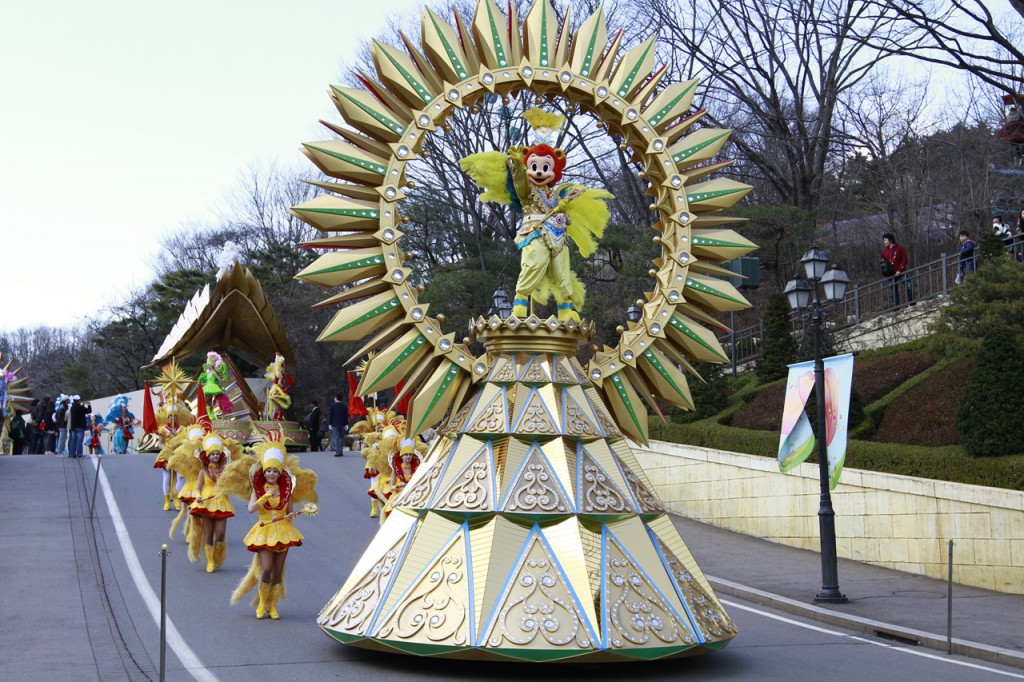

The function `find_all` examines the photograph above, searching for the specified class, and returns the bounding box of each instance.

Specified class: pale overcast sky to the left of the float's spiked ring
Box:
[0,0,424,331]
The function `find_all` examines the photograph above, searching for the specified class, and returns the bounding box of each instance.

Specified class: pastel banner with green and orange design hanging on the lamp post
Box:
[778,353,853,488]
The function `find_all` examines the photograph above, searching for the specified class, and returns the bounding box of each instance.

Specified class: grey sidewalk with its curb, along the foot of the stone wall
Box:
[672,516,1024,668]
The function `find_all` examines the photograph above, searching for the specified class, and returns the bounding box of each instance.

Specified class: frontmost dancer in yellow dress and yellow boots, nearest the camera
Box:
[231,434,317,620]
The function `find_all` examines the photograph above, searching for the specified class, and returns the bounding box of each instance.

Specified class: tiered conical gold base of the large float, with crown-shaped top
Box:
[317,318,736,662]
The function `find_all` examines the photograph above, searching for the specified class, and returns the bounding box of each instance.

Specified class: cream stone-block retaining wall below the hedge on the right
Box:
[635,440,1024,594]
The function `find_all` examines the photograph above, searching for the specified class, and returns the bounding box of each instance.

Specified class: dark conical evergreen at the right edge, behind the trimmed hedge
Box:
[956,321,1024,457]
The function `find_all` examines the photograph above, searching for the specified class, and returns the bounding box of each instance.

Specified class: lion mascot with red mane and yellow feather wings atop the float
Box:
[459,109,612,322]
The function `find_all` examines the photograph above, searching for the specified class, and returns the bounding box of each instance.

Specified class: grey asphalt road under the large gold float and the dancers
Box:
[61,454,1024,682]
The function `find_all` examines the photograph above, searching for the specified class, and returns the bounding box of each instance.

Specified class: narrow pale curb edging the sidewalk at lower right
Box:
[705,574,1024,669]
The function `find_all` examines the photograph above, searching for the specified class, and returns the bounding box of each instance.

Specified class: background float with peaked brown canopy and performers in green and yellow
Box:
[147,248,309,450]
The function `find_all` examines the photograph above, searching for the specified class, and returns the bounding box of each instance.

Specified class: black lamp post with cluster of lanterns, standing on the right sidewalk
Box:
[784,247,850,604]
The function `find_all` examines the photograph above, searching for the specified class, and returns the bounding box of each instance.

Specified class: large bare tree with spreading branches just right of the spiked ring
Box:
[636,0,890,212]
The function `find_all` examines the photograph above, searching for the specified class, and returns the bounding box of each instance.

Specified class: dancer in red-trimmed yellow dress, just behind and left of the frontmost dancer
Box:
[188,432,241,573]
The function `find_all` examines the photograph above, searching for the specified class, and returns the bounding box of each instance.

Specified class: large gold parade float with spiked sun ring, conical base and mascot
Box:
[293,0,755,663]
